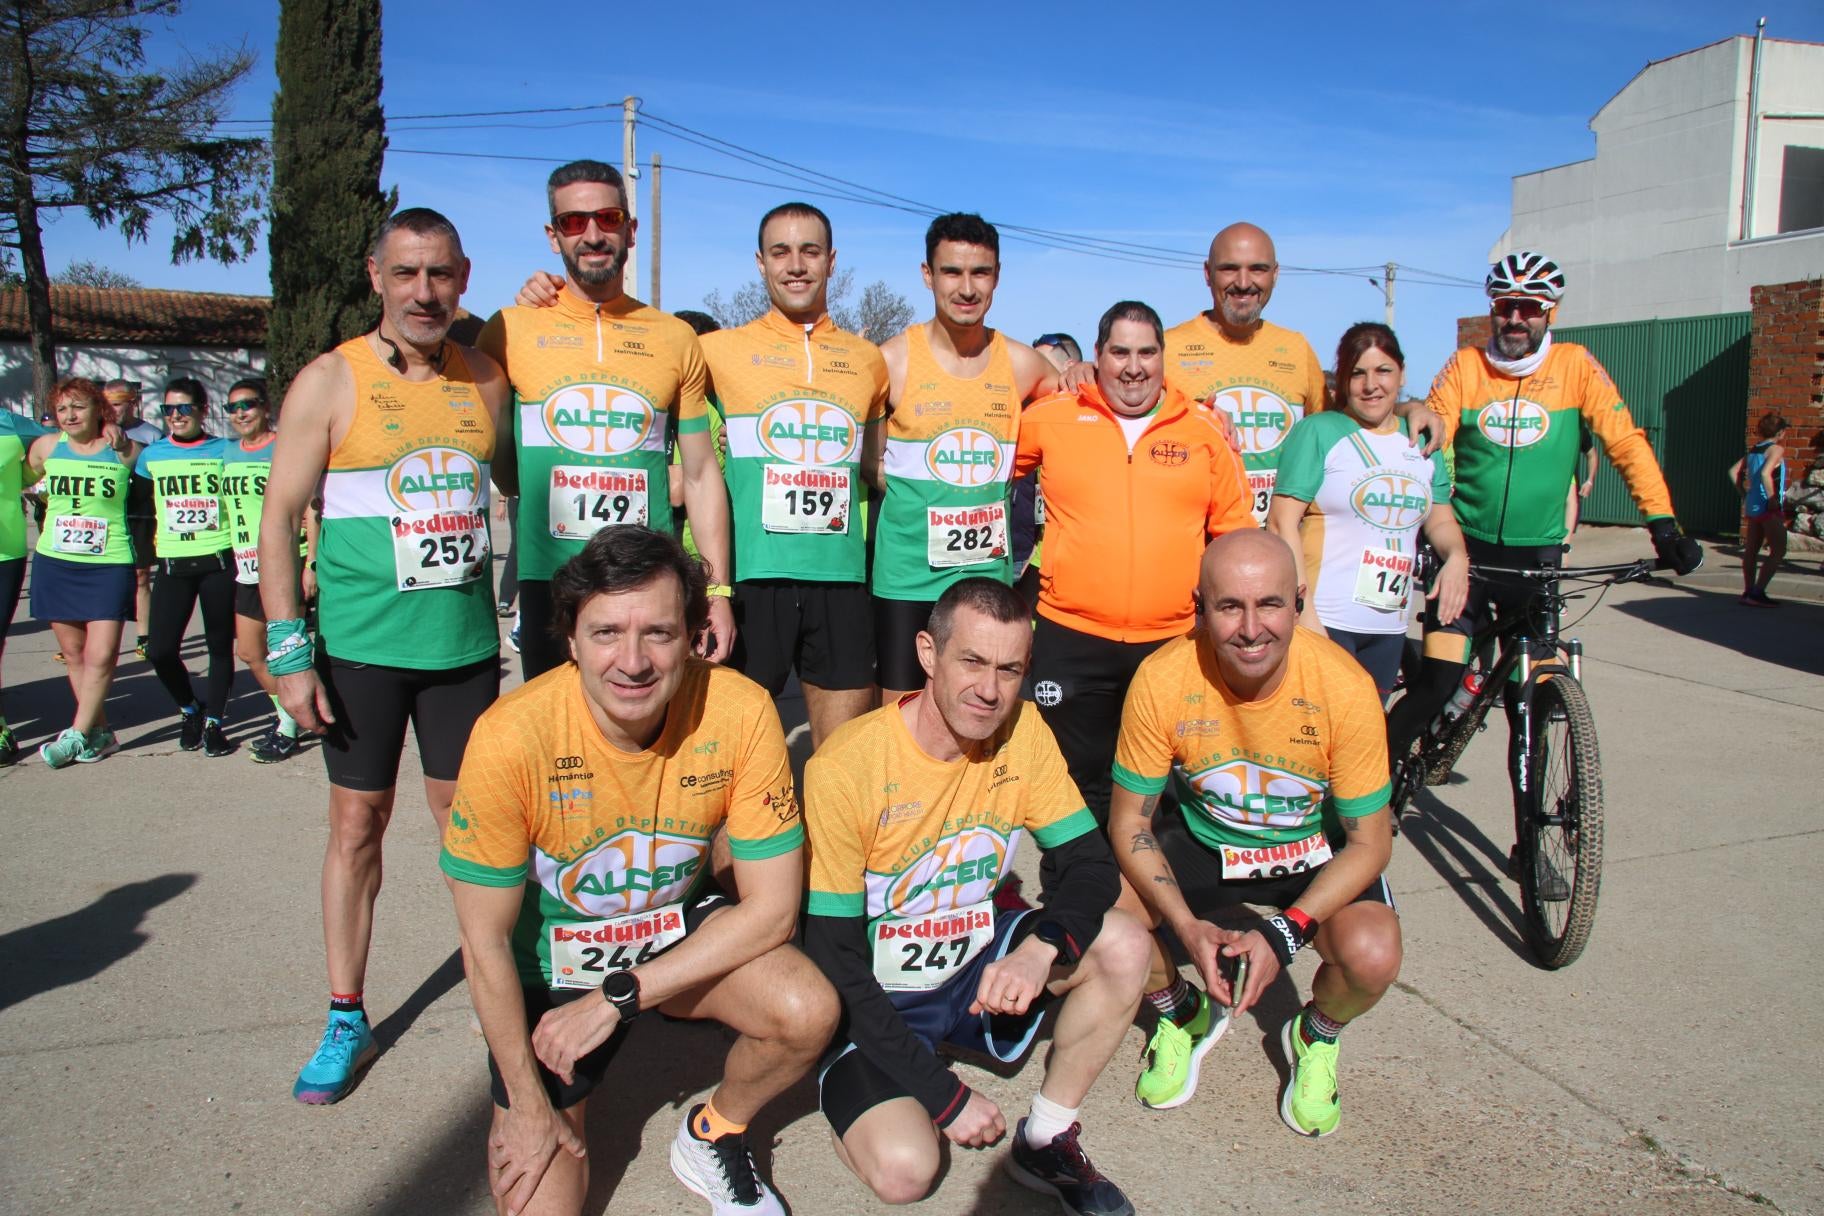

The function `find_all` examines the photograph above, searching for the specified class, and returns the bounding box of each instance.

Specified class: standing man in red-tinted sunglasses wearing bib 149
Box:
[492,160,735,680]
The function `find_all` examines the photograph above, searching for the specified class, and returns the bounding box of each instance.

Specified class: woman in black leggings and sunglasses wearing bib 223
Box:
[133,376,233,757]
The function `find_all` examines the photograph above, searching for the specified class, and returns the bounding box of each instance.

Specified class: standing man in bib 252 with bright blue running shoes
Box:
[259,208,516,1105]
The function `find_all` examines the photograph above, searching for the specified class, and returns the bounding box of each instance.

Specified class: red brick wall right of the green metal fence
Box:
[1742,279,1824,532]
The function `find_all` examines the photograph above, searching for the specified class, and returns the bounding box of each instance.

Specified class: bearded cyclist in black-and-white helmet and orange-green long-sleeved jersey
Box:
[1388,250,1704,901]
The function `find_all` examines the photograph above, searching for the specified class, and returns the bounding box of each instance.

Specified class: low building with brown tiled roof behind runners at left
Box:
[0,284,272,434]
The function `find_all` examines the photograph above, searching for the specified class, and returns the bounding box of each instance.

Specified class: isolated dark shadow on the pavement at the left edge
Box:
[0,873,197,1010]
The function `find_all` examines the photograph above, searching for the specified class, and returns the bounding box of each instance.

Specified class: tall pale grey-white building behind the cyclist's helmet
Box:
[1488,36,1824,325]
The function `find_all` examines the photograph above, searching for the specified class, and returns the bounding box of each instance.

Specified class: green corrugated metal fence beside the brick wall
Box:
[1552,312,1749,536]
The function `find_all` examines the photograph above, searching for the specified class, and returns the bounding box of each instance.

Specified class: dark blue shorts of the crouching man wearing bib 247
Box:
[817,908,1051,1138]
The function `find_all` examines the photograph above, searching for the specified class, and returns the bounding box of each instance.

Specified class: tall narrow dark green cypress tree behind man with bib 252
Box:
[266,0,394,401]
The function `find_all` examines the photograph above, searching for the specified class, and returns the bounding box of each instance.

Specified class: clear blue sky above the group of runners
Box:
[35,0,1824,392]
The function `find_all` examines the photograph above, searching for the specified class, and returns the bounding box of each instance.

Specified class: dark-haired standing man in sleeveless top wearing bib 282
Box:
[866,213,1058,706]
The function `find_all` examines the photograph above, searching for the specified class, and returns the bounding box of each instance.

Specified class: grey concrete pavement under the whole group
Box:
[0,531,1824,1216]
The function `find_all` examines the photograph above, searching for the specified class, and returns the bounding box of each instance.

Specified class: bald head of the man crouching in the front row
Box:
[1197,529,1299,700]
